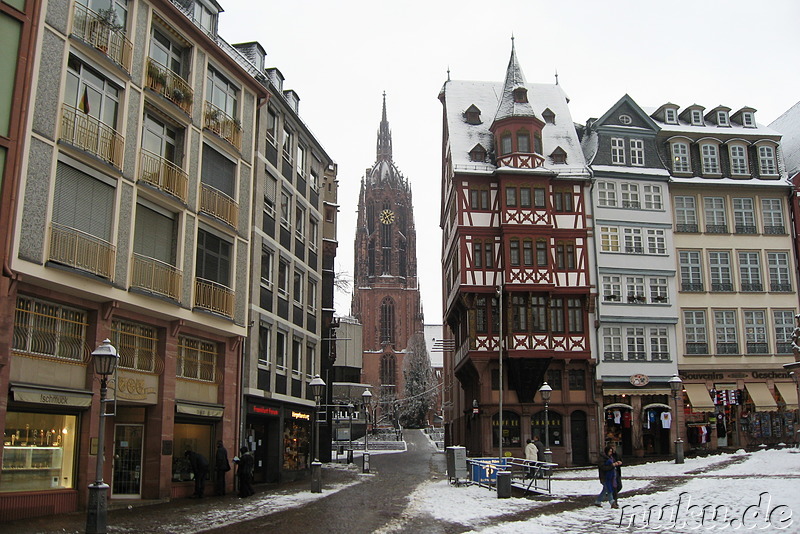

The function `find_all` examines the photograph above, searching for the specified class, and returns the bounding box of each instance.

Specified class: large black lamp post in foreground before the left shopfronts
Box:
[86,339,119,534]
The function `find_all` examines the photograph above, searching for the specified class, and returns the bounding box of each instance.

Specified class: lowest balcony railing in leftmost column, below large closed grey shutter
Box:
[49,223,116,280]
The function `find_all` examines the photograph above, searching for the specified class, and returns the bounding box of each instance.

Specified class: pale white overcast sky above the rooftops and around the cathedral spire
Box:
[219,0,800,324]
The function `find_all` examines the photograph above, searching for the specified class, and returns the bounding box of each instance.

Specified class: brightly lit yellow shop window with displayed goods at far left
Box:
[0,411,78,491]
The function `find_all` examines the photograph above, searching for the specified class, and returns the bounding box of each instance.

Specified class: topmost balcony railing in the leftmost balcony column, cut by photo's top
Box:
[72,2,133,74]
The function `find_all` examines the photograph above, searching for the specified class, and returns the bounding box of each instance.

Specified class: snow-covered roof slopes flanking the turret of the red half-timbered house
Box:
[444,80,586,172]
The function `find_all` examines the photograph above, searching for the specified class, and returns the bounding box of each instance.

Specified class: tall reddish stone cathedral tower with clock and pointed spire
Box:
[352,93,423,420]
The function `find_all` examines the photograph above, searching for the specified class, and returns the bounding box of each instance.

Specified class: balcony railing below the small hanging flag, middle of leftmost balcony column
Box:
[60,104,125,169]
